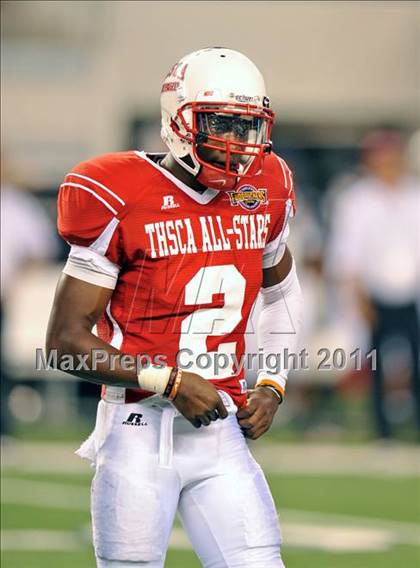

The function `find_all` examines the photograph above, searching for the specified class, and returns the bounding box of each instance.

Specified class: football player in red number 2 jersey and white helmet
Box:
[47,48,301,568]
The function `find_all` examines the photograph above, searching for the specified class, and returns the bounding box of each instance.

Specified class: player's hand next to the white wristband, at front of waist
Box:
[173,371,228,428]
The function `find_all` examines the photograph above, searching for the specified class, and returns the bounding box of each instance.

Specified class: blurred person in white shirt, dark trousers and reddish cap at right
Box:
[327,130,420,438]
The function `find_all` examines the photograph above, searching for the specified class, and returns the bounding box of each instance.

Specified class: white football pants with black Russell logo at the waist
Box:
[77,392,284,568]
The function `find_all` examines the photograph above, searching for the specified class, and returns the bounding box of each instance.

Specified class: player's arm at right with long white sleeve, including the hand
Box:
[237,246,302,440]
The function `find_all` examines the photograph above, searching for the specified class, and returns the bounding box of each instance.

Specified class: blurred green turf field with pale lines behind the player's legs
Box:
[1,446,420,568]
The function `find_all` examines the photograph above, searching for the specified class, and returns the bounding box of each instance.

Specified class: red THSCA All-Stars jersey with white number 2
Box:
[58,151,295,406]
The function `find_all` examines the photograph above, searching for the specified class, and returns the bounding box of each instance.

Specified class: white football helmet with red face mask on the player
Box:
[161,47,274,191]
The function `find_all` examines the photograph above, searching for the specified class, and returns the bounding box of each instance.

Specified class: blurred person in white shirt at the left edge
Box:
[0,163,58,435]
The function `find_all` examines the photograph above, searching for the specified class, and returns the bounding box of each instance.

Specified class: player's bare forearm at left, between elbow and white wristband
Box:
[46,328,139,388]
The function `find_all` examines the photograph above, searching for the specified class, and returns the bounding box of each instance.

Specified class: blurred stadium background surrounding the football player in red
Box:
[1,1,420,568]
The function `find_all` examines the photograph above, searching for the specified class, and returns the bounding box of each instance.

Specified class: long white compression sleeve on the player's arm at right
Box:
[257,261,303,392]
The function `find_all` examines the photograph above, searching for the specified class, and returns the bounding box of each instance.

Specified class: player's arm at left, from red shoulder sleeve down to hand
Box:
[46,158,227,427]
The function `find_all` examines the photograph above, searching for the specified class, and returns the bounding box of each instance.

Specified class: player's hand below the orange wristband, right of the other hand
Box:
[236,387,279,440]
